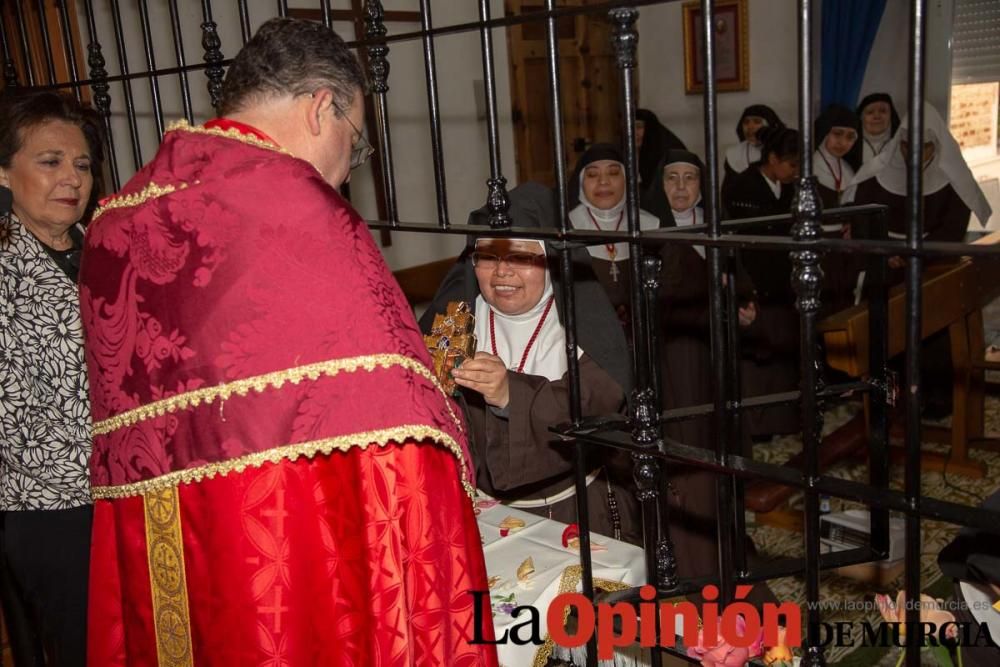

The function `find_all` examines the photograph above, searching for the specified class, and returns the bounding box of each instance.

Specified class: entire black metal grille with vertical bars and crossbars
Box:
[0,0,1000,667]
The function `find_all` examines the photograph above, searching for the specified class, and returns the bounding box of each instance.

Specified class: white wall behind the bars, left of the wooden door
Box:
[80,0,516,269]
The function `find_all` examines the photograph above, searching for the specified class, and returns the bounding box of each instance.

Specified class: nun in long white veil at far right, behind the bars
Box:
[843,104,992,260]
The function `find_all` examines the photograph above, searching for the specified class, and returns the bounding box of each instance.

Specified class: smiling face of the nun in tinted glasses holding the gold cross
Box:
[472,239,546,315]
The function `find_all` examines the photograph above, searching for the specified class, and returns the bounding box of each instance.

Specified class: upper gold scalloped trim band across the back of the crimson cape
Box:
[94,354,462,435]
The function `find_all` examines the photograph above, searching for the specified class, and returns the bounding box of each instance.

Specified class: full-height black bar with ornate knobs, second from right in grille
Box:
[791,0,826,667]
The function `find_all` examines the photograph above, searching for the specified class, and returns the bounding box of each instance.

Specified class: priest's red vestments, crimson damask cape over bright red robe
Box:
[80,125,496,667]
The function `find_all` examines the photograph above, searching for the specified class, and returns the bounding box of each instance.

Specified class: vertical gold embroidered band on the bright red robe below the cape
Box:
[143,488,194,667]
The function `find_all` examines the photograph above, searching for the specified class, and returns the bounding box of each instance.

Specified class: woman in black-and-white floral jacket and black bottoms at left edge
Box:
[0,92,101,667]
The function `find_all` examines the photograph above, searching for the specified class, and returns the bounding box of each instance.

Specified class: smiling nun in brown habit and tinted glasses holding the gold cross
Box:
[421,183,641,543]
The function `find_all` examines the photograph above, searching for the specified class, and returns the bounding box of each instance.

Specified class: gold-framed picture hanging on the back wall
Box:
[683,0,750,94]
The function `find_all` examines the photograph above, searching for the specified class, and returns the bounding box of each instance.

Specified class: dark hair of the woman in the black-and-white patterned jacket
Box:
[0,88,104,171]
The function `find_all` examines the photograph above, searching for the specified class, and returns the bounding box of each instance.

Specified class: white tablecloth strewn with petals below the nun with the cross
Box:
[478,503,646,667]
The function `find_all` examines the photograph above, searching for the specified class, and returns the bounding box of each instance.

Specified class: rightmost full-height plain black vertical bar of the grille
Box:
[903,0,927,667]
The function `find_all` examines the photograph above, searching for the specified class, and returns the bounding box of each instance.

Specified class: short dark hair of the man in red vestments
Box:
[219,18,365,116]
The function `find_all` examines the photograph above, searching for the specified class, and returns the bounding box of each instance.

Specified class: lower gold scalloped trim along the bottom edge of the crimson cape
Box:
[90,424,475,500]
